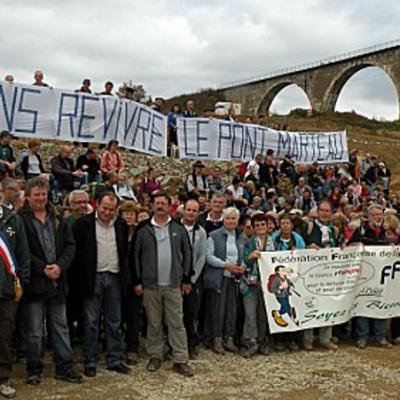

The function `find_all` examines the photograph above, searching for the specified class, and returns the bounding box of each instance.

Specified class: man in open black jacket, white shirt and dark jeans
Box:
[73,192,133,377]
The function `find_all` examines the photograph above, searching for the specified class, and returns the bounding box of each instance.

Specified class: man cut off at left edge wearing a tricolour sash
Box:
[0,205,31,399]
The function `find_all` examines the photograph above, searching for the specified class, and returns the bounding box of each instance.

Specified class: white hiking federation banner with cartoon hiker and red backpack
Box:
[259,246,400,333]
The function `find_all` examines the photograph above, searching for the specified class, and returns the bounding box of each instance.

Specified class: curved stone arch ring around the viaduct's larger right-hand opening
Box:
[323,61,400,112]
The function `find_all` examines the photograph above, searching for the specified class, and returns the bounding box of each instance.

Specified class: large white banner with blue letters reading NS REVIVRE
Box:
[0,82,167,156]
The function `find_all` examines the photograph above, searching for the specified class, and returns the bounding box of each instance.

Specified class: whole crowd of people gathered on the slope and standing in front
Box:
[0,71,400,398]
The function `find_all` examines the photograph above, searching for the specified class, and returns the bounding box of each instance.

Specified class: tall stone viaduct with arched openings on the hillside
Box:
[219,40,400,118]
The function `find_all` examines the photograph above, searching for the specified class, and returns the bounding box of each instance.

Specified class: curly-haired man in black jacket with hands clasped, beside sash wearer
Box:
[20,177,82,385]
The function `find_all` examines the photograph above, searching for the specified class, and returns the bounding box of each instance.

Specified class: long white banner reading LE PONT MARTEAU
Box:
[178,118,348,164]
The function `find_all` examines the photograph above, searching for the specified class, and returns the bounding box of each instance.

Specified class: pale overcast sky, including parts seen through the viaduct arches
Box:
[0,0,400,119]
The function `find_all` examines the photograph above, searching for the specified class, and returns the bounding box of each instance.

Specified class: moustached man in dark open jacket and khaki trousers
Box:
[130,192,193,377]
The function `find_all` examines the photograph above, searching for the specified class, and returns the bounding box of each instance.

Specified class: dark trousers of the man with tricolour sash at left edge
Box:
[0,299,15,384]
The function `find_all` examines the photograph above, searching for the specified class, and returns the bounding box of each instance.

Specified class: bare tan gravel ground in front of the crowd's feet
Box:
[12,345,400,400]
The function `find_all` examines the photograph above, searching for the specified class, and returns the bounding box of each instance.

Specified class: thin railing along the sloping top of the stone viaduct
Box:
[217,39,400,89]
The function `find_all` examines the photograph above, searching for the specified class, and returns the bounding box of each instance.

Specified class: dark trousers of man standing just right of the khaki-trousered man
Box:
[183,279,203,351]
